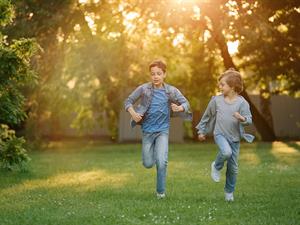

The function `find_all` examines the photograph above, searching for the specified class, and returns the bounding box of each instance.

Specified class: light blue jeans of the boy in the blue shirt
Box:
[142,131,169,193]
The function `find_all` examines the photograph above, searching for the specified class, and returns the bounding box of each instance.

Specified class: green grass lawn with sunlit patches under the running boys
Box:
[0,142,300,225]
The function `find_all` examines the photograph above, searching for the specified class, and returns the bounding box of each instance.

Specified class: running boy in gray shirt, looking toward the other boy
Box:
[196,69,254,201]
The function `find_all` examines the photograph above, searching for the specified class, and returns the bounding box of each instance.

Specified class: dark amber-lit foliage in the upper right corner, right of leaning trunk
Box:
[227,0,300,98]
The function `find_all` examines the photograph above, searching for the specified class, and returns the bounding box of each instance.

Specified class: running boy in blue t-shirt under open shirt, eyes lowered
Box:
[125,60,192,198]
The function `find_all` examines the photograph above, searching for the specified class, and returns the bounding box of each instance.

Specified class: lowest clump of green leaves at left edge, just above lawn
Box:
[0,124,30,170]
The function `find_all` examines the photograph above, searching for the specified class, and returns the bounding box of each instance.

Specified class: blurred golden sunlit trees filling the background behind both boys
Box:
[1,0,300,140]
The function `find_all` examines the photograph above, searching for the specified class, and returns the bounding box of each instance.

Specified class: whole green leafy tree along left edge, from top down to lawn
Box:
[0,0,38,169]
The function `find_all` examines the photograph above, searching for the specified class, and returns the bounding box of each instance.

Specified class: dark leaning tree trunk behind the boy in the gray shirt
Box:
[210,14,276,141]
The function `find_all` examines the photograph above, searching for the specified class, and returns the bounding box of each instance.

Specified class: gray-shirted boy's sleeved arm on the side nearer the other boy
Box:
[196,97,216,136]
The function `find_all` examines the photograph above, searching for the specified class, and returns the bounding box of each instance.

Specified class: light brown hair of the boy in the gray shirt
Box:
[218,68,243,94]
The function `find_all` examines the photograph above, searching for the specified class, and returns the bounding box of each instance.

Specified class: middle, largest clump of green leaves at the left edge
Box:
[0,14,39,125]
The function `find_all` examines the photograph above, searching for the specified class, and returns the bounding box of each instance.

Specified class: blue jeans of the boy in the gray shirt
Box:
[214,134,240,193]
